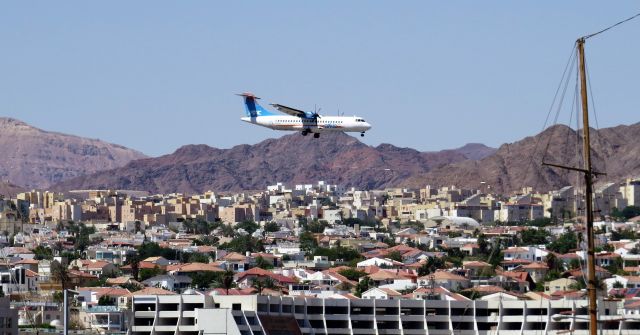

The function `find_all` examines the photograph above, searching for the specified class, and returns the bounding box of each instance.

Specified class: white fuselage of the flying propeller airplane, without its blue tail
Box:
[242,115,371,133]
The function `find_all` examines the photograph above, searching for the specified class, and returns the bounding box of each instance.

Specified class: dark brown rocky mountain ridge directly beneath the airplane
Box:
[56,133,495,193]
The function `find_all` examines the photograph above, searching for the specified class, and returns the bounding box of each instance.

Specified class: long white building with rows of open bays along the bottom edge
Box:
[130,295,640,335]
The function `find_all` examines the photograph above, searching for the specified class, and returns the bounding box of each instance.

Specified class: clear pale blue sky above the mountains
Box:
[0,0,640,156]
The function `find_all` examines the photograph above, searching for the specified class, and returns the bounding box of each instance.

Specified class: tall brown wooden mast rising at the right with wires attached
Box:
[576,37,598,335]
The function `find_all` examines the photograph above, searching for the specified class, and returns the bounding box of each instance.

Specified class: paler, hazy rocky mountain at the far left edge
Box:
[0,117,146,189]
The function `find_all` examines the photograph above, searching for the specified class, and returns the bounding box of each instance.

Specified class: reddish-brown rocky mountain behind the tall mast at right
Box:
[404,123,640,192]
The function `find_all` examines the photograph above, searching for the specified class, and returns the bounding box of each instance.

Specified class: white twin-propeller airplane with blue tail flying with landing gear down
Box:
[237,93,371,138]
